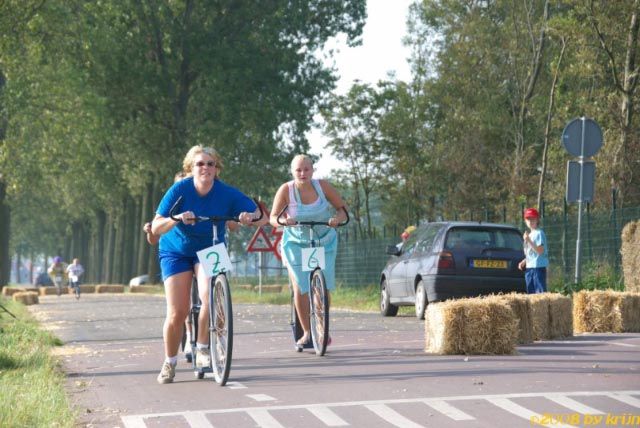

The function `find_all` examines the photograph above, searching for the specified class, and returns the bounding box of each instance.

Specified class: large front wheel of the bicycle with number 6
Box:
[309,269,329,356]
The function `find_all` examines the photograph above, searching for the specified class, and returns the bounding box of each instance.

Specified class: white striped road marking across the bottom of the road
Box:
[122,390,640,428]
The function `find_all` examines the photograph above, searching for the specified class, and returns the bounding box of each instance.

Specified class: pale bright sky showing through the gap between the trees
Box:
[307,0,413,178]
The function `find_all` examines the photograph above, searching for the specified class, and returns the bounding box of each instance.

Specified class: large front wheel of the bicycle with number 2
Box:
[209,274,233,386]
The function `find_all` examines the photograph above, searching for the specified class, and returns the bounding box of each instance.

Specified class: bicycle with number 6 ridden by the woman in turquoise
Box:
[276,205,349,356]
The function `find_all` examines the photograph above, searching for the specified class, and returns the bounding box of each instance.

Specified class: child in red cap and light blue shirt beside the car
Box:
[518,208,549,294]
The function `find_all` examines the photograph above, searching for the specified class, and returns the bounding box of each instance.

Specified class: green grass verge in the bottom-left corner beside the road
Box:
[0,298,76,427]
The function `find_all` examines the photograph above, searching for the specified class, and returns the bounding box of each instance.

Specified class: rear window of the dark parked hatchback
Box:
[445,227,522,251]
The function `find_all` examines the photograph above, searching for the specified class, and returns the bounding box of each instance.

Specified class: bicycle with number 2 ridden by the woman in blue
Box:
[169,197,264,386]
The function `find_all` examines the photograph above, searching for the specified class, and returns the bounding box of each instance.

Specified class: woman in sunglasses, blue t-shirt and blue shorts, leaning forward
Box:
[151,146,266,383]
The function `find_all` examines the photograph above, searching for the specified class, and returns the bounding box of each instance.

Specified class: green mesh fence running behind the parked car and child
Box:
[232,200,640,287]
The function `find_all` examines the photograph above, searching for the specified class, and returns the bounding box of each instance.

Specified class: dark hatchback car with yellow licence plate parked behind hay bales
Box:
[380,222,526,319]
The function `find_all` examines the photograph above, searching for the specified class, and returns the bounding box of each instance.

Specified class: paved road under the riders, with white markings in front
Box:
[30,294,640,428]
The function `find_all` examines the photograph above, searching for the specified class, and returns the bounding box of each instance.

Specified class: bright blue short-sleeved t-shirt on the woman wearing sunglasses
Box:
[156,177,257,257]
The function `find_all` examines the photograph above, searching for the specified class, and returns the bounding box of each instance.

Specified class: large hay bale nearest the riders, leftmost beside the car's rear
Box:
[425,296,518,355]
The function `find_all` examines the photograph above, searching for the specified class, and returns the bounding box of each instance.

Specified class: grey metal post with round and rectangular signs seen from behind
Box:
[562,117,602,284]
